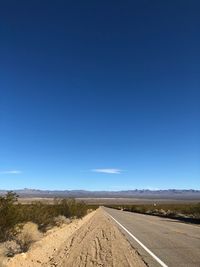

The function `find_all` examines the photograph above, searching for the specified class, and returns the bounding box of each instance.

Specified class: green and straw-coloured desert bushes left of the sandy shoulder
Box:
[0,192,95,256]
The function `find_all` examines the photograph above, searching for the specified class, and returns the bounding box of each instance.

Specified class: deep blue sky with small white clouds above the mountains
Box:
[0,0,200,190]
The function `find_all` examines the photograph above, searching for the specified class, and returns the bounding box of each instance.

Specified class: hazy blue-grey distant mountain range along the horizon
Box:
[0,188,200,200]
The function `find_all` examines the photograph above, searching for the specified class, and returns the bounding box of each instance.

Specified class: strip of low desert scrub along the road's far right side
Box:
[108,203,200,223]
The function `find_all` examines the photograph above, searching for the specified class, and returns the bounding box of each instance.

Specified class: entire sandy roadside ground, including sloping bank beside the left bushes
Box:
[4,209,146,267]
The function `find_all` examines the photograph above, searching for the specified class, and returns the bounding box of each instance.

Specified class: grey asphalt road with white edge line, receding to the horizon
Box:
[103,207,200,267]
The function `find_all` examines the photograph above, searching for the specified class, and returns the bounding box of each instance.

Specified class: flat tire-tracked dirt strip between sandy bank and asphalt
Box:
[46,209,146,267]
